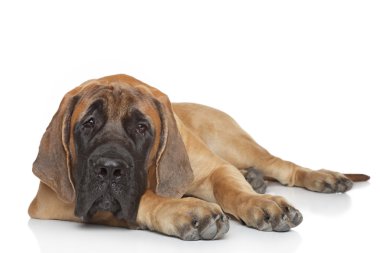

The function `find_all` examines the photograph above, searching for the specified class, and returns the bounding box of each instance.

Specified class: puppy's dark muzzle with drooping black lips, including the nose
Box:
[75,146,145,221]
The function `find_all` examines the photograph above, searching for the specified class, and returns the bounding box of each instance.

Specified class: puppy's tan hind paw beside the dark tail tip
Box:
[303,170,353,193]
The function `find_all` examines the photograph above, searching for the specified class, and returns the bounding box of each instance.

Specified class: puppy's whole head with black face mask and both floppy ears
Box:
[33,75,193,222]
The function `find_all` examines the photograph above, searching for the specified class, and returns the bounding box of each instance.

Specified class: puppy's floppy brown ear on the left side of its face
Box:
[33,88,79,202]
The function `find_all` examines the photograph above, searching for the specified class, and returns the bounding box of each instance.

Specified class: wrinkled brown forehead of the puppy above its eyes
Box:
[73,80,159,122]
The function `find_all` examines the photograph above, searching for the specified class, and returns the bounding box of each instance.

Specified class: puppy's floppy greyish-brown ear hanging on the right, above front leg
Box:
[155,92,193,198]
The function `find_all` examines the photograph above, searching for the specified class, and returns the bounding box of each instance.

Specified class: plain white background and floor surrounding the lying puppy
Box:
[0,0,380,252]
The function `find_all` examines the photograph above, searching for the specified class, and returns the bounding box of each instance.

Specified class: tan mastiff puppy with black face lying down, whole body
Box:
[29,75,369,240]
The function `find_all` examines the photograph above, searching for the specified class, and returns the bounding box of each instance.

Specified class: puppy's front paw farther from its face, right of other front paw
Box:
[238,195,302,232]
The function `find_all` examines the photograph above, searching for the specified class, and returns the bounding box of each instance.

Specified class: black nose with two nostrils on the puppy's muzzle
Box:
[95,157,128,179]
